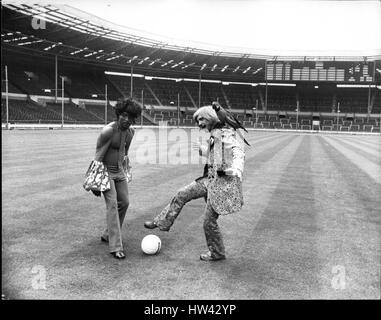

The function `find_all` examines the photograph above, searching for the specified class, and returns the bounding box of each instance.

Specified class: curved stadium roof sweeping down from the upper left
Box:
[1,3,381,80]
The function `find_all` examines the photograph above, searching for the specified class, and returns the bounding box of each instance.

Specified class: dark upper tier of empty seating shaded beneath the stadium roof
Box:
[2,65,381,113]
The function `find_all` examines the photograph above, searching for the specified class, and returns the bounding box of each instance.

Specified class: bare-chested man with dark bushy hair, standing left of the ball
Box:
[93,98,142,259]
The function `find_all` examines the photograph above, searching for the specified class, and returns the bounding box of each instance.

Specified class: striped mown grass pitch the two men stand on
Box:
[2,129,381,300]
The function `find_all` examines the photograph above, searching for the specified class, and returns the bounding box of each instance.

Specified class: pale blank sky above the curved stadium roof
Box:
[6,0,381,55]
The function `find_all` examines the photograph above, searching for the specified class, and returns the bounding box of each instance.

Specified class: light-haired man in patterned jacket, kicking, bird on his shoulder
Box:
[144,106,245,261]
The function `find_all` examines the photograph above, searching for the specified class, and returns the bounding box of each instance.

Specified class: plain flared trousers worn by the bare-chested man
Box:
[102,168,129,252]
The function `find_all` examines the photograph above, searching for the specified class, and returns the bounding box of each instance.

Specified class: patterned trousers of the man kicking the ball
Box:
[154,178,225,257]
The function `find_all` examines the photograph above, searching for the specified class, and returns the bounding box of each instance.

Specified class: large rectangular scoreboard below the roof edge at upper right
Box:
[266,61,374,83]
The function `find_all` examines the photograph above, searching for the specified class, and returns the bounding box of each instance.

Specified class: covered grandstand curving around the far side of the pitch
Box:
[1,5,381,132]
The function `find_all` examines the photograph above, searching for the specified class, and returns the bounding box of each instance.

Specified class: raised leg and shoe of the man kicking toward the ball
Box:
[144,178,207,231]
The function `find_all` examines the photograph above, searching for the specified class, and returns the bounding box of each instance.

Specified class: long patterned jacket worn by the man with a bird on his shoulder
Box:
[200,127,245,215]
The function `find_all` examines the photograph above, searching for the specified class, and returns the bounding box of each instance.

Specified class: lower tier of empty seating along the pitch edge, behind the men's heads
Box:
[1,99,381,132]
